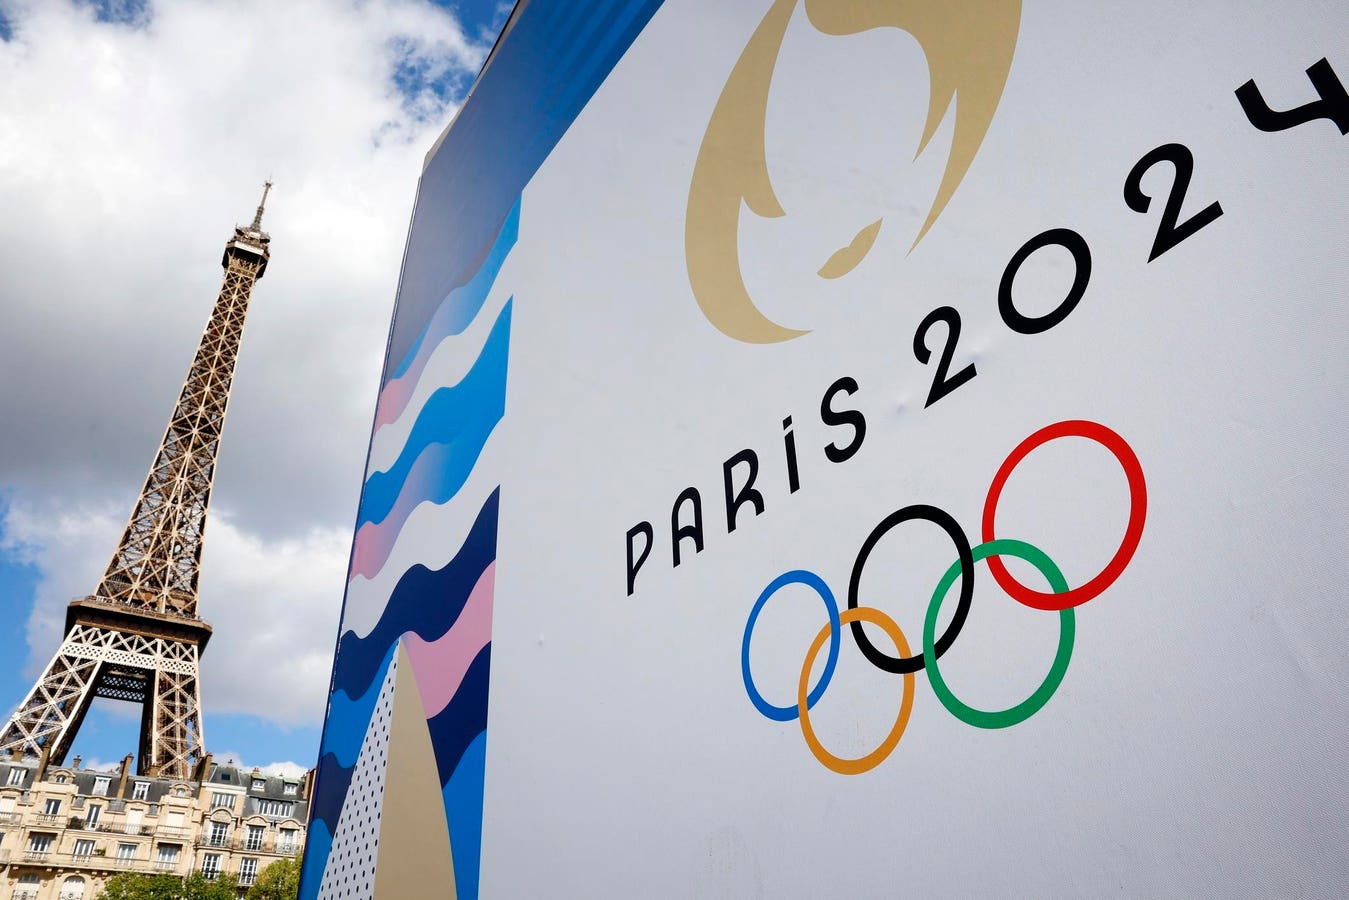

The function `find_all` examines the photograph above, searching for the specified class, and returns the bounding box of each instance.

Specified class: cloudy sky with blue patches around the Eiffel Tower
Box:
[0,0,509,768]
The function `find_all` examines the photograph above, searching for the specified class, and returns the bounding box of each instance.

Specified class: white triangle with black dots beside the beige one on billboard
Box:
[318,654,398,900]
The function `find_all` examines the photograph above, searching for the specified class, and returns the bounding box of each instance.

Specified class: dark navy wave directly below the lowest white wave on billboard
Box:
[329,487,500,701]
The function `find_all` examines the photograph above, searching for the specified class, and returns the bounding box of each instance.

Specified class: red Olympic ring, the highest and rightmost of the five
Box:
[983,420,1148,611]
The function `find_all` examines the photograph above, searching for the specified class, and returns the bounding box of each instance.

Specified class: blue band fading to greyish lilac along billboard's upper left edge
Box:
[382,0,661,383]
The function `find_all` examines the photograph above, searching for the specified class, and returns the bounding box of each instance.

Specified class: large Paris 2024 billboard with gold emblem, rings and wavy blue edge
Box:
[302,0,1349,897]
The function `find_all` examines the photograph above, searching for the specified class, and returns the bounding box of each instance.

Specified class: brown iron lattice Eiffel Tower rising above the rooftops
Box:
[0,182,271,779]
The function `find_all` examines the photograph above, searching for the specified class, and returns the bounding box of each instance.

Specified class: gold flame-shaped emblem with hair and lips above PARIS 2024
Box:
[684,0,1021,344]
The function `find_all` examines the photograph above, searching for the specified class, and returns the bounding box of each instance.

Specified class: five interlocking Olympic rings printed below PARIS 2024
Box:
[741,420,1148,775]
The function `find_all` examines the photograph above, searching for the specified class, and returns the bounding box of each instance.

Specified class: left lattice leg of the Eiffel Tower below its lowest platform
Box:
[0,626,104,765]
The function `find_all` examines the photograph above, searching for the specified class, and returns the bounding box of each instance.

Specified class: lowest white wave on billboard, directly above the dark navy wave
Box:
[341,425,505,637]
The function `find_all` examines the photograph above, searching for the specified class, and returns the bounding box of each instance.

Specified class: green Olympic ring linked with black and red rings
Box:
[923,538,1077,729]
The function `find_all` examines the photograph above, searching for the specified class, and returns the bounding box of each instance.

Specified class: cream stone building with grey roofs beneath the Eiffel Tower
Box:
[0,754,313,900]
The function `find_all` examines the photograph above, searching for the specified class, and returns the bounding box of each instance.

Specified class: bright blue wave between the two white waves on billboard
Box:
[356,302,511,528]
